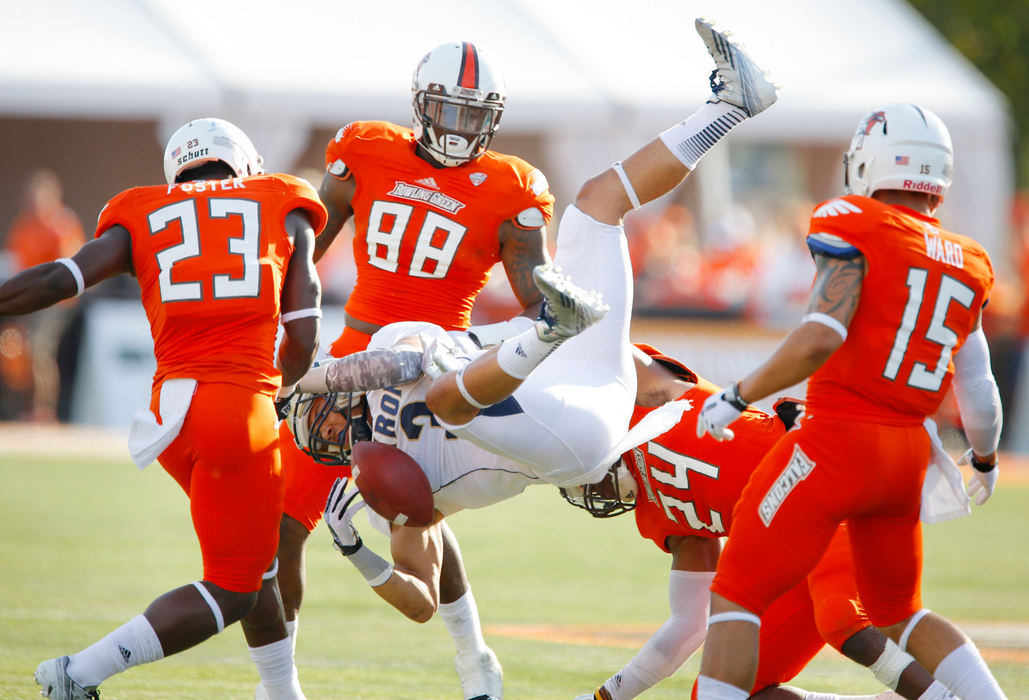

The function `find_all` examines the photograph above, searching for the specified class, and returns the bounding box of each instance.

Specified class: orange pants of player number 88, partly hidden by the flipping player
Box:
[279,327,371,532]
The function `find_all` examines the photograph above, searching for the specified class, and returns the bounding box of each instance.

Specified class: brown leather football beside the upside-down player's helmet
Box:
[351,441,435,527]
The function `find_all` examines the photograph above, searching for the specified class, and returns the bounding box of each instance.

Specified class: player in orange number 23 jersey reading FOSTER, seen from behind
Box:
[0,118,325,700]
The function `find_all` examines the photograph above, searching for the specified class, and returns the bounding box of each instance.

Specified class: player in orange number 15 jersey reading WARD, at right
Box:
[698,104,1004,700]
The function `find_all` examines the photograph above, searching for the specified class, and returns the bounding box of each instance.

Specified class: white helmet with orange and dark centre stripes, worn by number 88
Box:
[411,41,507,168]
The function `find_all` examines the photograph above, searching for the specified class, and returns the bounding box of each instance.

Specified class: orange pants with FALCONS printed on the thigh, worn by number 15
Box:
[711,416,929,626]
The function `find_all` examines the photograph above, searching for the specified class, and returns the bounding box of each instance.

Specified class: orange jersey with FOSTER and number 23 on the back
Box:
[96,174,326,393]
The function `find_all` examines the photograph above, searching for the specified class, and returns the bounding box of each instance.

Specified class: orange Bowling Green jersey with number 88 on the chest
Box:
[325,121,554,330]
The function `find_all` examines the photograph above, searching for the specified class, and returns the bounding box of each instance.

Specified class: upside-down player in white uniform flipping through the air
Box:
[281,20,777,697]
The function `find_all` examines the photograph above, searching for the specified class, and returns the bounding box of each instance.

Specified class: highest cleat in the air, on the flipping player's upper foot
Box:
[697,18,779,116]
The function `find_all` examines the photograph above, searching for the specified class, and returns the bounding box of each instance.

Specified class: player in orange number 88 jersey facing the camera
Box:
[269,42,554,698]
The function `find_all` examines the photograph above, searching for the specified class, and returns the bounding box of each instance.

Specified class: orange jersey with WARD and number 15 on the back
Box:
[807,195,993,425]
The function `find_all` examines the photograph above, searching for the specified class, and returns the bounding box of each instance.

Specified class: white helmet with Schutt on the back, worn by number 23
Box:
[165,117,264,184]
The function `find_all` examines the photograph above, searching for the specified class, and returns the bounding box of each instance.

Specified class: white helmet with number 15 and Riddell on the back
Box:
[843,104,954,200]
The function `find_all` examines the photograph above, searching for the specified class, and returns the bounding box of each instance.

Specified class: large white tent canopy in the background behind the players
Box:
[0,0,1014,254]
